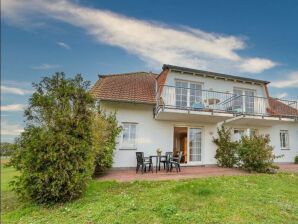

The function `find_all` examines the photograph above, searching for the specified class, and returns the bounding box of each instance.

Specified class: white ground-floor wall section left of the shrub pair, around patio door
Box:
[101,102,216,167]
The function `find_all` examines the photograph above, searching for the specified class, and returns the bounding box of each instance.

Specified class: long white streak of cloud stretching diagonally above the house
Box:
[2,0,276,73]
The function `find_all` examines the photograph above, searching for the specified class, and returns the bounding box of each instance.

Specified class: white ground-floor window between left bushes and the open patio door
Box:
[120,122,137,149]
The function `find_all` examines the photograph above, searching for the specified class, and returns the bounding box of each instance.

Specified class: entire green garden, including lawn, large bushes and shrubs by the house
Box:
[1,73,298,223]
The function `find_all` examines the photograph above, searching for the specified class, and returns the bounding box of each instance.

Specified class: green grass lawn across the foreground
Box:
[1,164,298,224]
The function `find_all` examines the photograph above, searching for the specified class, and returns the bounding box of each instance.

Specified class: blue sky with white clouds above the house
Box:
[1,0,298,142]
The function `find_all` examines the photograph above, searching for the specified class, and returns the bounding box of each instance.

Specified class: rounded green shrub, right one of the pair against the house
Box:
[238,135,280,173]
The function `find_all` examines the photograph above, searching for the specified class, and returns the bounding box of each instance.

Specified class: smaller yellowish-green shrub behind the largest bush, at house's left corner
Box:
[92,109,121,176]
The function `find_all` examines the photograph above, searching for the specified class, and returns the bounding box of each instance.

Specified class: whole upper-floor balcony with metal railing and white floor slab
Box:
[155,86,298,124]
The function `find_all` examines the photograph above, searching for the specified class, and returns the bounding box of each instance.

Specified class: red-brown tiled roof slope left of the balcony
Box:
[91,72,157,104]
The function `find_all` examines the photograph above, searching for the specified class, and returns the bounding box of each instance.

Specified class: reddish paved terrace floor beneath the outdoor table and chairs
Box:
[98,164,298,182]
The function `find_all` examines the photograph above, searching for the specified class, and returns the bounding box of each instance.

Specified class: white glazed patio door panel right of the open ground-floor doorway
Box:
[188,128,202,165]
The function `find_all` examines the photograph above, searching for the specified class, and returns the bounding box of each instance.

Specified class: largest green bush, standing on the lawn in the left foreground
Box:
[11,73,95,203]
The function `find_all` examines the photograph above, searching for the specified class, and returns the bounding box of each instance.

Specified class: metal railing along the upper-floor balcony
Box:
[156,85,298,118]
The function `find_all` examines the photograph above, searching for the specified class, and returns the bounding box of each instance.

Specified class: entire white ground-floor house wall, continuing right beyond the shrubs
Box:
[101,102,298,167]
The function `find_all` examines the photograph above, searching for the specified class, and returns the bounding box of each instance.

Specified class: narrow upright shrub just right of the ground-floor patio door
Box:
[213,126,238,167]
